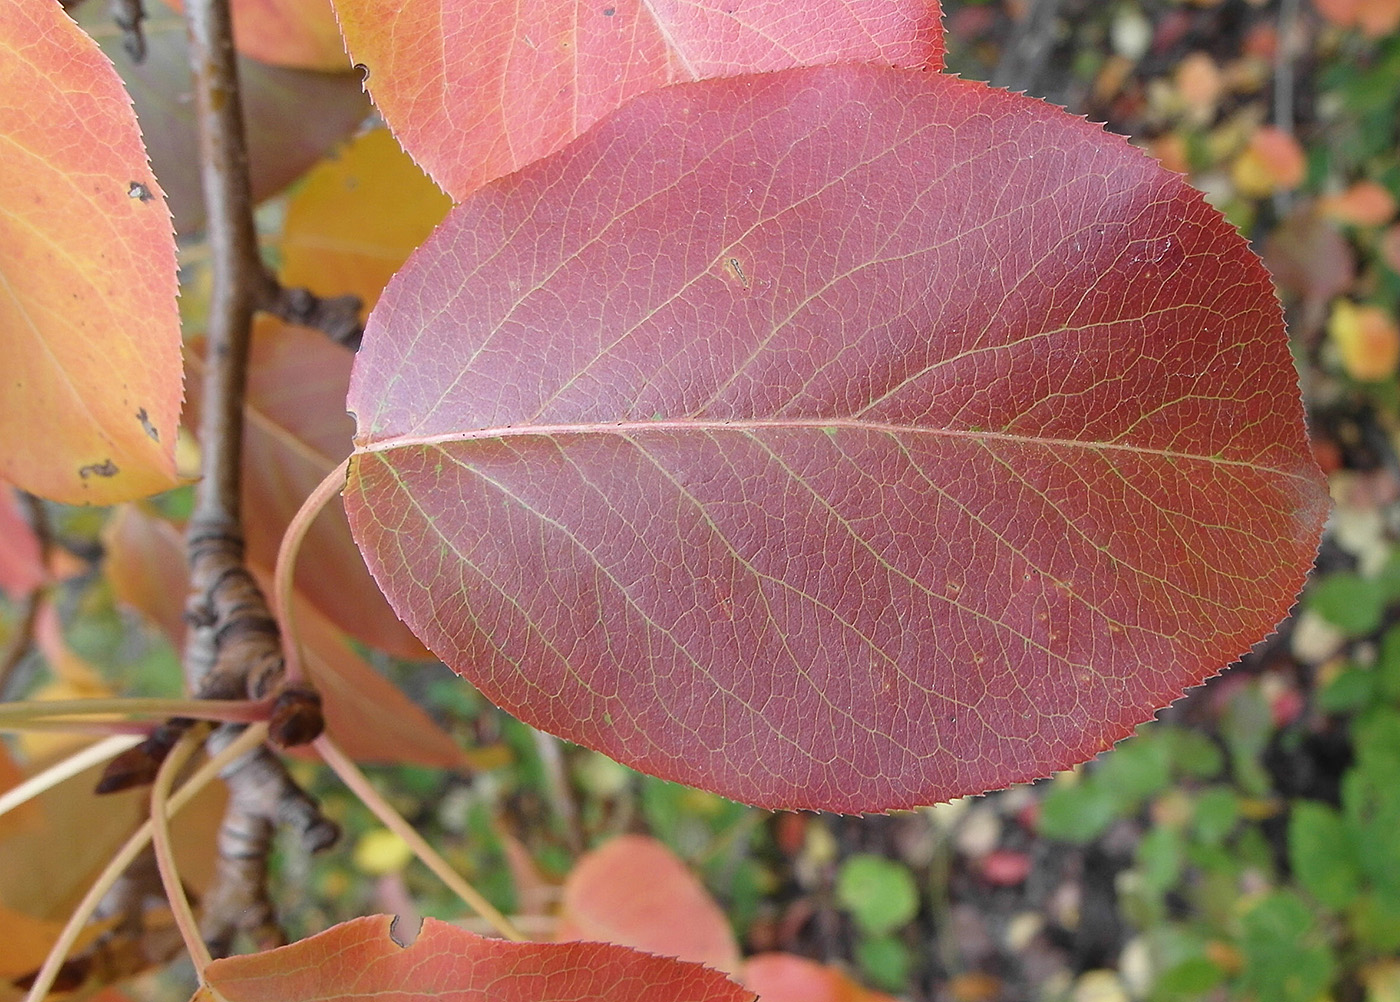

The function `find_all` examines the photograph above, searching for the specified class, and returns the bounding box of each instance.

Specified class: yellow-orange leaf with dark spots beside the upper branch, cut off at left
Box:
[0,0,181,504]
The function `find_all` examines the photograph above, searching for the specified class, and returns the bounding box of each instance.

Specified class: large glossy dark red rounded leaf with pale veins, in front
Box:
[346,66,1327,812]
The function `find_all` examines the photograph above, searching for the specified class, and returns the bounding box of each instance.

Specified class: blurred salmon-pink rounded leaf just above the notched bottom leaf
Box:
[554,835,739,971]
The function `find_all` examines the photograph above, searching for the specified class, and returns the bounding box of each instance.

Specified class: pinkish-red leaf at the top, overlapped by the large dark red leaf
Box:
[333,0,944,199]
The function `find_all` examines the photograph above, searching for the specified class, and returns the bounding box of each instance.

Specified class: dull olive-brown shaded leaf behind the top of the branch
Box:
[74,3,370,234]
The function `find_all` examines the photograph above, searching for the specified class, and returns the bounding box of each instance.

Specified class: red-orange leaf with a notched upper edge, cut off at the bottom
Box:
[195,915,753,1002]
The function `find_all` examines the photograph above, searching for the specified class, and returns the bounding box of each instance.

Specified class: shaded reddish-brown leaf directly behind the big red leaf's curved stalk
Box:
[186,316,426,658]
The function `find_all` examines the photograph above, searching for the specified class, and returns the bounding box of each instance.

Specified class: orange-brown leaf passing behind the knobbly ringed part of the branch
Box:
[104,508,470,768]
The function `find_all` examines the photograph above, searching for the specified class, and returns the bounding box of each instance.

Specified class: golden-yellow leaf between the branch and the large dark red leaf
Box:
[281,129,452,309]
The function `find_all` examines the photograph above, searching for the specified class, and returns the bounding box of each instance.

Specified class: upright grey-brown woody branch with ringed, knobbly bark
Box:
[176,0,336,956]
